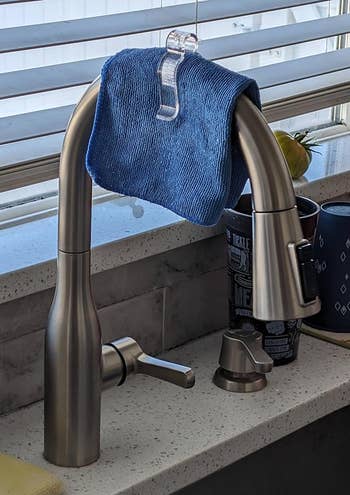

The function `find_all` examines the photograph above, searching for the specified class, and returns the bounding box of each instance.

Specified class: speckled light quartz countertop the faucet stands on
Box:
[0,333,350,495]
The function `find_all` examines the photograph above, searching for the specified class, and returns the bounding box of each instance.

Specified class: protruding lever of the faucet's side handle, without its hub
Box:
[103,337,195,388]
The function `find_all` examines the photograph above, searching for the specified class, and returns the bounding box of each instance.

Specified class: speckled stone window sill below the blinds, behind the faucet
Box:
[0,135,350,303]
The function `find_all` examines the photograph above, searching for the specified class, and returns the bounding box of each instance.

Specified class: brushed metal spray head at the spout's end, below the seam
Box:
[253,207,321,321]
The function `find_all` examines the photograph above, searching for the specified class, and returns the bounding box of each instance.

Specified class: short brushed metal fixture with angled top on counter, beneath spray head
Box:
[213,329,273,392]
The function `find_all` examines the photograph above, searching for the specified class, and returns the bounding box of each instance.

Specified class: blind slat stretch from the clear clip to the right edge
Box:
[200,14,350,60]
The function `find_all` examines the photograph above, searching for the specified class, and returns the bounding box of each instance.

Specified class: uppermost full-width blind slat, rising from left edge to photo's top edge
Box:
[0,0,326,53]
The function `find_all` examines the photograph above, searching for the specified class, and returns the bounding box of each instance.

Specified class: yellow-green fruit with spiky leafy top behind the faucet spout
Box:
[274,131,318,179]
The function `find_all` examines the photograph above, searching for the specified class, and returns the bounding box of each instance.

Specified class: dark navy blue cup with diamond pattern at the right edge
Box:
[305,201,350,333]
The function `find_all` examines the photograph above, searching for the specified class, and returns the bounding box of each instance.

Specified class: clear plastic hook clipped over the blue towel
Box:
[157,30,198,121]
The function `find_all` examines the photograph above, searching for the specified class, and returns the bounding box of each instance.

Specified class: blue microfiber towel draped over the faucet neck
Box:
[86,48,260,226]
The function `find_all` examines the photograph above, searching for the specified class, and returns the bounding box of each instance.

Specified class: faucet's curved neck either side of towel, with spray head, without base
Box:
[59,78,319,320]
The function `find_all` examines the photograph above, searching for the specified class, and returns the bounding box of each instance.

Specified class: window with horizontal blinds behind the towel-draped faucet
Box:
[0,0,350,197]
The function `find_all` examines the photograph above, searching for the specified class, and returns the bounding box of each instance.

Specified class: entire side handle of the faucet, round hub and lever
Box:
[102,337,195,388]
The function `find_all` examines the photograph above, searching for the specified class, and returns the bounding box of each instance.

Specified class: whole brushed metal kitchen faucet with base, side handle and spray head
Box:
[44,78,319,467]
